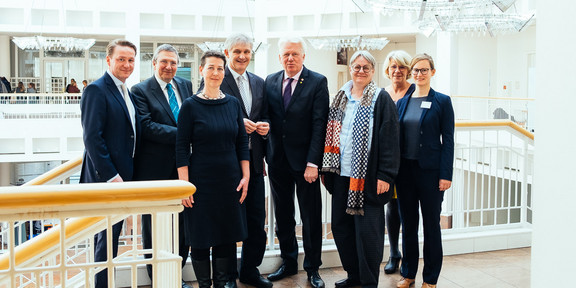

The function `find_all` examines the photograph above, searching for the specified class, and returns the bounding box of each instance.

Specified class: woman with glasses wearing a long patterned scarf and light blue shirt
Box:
[321,51,400,288]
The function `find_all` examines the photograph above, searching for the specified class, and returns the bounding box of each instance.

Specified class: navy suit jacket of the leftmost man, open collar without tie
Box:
[80,72,140,183]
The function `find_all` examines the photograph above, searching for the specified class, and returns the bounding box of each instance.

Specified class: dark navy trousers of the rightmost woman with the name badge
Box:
[396,158,444,284]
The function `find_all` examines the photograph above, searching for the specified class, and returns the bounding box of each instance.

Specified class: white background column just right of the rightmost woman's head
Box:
[434,32,458,95]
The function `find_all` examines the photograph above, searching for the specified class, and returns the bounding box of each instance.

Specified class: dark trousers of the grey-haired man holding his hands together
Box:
[230,164,267,279]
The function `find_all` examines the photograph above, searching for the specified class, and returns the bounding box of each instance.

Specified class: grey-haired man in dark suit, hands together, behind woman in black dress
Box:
[199,34,272,288]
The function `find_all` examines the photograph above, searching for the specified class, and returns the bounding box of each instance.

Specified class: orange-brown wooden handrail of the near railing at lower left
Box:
[0,180,196,270]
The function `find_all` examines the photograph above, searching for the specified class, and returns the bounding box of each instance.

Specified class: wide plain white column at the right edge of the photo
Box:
[530,0,576,287]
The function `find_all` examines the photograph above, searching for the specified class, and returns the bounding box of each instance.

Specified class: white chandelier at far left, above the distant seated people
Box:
[12,36,96,52]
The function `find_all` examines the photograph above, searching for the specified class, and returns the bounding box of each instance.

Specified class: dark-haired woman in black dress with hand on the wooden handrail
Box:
[176,51,250,287]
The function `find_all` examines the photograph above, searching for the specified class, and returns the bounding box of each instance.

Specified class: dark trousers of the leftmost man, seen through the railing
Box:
[94,220,124,288]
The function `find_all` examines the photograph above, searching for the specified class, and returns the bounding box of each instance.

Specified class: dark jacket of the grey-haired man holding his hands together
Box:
[198,66,270,173]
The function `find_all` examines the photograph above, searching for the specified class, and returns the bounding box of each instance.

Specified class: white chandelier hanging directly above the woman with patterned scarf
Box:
[308,36,390,51]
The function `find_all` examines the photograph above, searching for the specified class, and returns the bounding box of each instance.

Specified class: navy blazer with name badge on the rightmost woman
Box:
[397,89,454,181]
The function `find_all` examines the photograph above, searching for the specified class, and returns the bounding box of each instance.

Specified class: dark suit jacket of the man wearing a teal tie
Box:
[132,76,193,180]
